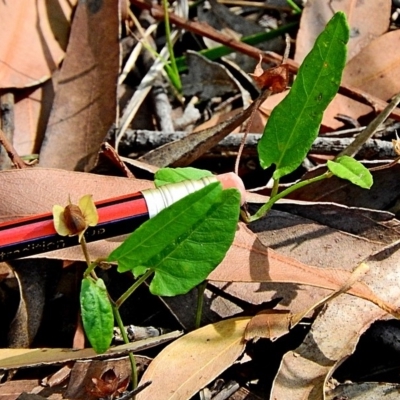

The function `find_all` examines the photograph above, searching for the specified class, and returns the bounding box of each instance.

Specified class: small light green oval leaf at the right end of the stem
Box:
[327,156,373,189]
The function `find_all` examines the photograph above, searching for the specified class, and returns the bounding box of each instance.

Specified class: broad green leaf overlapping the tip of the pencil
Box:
[108,182,240,296]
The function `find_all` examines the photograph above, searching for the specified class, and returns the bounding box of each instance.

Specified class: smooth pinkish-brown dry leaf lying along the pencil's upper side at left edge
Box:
[0,168,154,222]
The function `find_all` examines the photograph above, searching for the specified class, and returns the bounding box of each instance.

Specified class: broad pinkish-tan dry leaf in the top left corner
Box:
[0,0,77,88]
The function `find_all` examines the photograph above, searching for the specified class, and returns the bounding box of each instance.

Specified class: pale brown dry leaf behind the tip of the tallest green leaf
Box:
[294,0,391,63]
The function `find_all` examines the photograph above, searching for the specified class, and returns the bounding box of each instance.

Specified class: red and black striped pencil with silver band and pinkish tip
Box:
[0,173,244,261]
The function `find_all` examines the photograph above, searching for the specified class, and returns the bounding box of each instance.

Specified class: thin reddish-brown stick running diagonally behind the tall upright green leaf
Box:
[130,0,400,121]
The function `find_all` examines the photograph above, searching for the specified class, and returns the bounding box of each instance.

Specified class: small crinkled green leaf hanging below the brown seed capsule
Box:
[80,278,114,353]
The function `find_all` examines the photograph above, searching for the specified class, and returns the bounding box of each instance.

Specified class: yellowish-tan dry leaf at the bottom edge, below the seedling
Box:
[136,318,250,400]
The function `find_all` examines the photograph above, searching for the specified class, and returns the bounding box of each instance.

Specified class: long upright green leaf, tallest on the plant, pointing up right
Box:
[258,12,349,179]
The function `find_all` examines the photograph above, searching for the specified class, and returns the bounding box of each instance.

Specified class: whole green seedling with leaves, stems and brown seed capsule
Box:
[54,12,373,387]
